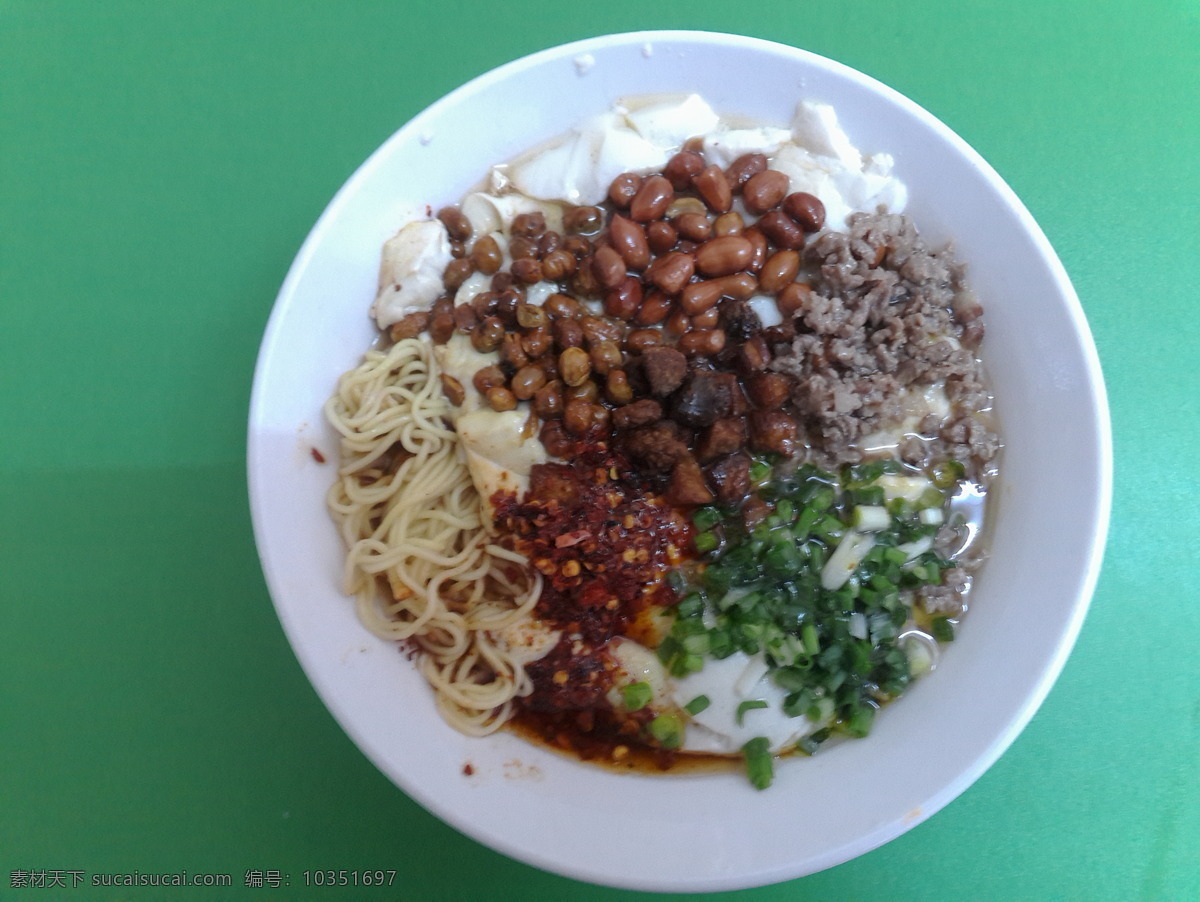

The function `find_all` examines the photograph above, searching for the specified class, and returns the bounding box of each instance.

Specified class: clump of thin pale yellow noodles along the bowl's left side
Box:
[325,338,541,735]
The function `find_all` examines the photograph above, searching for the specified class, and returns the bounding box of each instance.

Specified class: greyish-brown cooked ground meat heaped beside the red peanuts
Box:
[772,214,1000,479]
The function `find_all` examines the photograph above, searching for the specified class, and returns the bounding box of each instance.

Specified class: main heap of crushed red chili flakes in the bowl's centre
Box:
[493,443,691,644]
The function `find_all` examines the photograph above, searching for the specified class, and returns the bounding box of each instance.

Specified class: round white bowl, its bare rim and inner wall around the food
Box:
[248,31,1111,891]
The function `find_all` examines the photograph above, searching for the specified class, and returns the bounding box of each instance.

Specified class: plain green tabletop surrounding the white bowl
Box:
[0,0,1200,900]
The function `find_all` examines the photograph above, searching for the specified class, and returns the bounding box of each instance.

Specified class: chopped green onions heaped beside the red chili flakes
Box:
[652,457,965,786]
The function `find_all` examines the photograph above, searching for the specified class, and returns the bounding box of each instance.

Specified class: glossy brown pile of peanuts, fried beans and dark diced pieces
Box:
[391,146,824,505]
